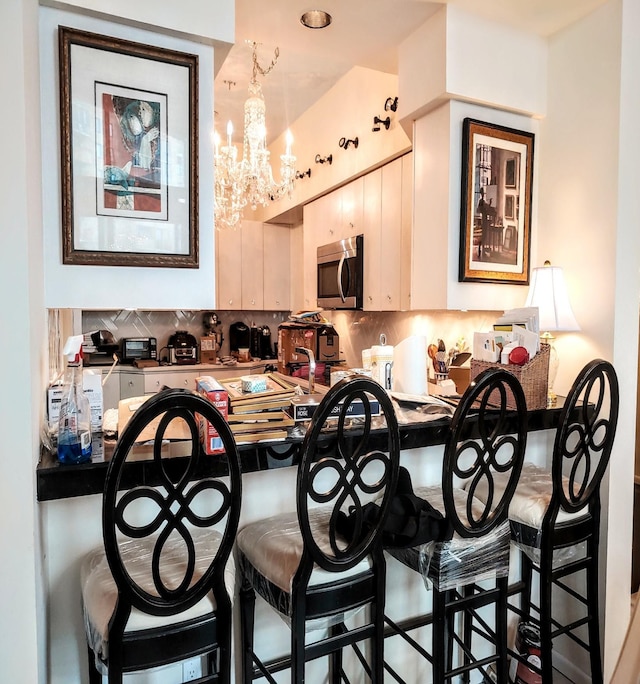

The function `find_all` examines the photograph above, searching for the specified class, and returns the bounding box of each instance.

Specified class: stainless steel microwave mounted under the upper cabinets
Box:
[318,235,364,309]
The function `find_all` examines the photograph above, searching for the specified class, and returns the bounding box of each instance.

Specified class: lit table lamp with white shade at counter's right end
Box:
[525,261,580,406]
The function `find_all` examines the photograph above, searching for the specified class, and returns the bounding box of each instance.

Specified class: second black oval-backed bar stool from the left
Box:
[236,376,400,684]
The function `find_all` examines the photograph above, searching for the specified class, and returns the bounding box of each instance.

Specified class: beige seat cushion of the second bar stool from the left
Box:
[236,508,371,593]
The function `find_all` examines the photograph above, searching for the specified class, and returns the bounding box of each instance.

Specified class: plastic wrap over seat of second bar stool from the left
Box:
[236,507,371,632]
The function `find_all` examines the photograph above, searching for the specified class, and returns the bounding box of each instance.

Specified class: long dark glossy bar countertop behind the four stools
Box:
[36,398,562,501]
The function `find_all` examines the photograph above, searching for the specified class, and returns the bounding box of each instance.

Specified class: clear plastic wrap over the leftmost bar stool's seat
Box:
[80,529,235,673]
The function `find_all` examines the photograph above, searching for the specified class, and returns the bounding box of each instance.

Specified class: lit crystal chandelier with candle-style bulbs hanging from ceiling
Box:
[214,42,296,229]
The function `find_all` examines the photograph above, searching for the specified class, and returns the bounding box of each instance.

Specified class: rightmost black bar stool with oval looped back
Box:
[480,359,619,682]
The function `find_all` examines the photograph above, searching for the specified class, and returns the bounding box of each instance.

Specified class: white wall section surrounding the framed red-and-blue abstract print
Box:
[40,3,220,309]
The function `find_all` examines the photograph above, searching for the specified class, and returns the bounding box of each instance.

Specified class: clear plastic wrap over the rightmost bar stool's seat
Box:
[476,463,583,567]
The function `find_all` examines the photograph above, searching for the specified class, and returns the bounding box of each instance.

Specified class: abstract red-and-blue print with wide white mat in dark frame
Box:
[58,26,198,268]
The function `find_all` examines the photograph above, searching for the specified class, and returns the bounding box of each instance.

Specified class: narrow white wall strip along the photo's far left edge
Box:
[0,0,46,684]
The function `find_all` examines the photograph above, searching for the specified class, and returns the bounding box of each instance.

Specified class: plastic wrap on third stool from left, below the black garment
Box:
[389,486,511,591]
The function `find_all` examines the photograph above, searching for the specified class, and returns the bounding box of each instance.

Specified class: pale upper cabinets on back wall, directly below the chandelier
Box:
[216,221,291,311]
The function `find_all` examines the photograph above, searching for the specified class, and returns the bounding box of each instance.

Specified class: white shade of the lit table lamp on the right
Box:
[526,265,580,332]
